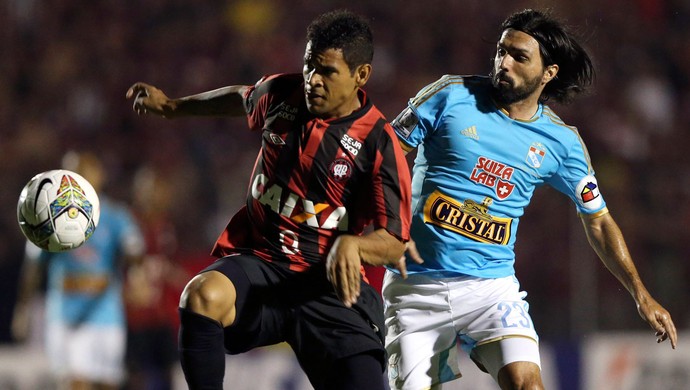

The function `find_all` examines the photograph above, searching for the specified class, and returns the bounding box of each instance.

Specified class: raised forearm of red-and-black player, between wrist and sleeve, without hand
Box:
[171,85,247,117]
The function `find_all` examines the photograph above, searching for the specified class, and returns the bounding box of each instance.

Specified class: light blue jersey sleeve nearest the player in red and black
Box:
[391,75,463,149]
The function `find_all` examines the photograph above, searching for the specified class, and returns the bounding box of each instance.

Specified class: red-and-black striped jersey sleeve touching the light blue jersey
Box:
[373,123,412,241]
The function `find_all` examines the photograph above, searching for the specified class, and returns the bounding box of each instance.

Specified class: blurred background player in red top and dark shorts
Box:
[124,165,191,390]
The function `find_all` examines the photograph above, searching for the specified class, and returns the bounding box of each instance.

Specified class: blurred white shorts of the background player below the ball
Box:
[46,323,127,385]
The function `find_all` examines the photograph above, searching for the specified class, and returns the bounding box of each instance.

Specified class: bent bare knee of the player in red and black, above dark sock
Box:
[180,271,236,326]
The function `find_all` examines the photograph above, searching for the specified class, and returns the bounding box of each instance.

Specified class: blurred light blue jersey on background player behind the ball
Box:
[27,197,144,326]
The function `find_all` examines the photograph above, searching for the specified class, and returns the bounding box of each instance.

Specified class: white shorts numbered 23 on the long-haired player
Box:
[383,271,541,390]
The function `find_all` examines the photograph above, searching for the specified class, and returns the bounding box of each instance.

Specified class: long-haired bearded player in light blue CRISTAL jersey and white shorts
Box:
[383,10,677,390]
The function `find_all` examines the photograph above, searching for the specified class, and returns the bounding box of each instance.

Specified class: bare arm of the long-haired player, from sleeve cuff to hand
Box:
[582,212,678,349]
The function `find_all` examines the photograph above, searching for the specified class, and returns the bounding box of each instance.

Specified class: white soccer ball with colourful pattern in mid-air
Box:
[17,169,101,252]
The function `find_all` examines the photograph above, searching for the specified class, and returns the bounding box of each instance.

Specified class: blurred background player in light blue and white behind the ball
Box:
[12,152,144,390]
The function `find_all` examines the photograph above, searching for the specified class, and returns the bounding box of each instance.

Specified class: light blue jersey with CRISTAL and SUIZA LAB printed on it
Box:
[393,75,606,278]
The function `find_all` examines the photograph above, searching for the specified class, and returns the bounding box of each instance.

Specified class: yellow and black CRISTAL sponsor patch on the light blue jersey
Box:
[424,191,513,245]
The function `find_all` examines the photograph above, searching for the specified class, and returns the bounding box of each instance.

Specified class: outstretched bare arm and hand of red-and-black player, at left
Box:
[126,82,248,118]
